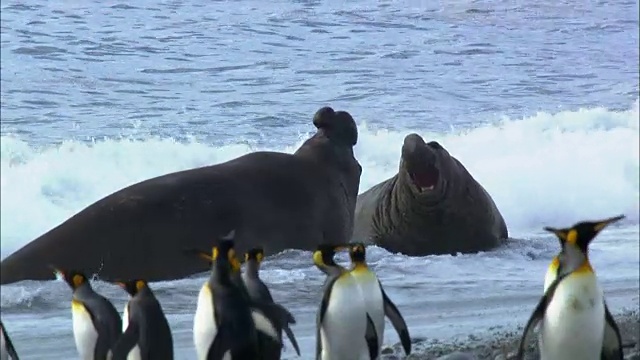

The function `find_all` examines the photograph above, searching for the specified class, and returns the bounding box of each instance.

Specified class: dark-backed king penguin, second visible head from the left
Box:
[113,279,173,360]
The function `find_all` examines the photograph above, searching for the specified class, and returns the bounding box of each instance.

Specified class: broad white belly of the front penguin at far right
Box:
[539,274,605,360]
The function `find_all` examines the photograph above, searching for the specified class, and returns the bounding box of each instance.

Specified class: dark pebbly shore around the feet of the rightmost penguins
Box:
[381,311,640,360]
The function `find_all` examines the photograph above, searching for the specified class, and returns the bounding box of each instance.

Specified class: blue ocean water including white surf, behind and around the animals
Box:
[0,0,640,359]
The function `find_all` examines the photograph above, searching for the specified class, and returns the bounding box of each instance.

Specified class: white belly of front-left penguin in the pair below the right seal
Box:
[320,275,369,360]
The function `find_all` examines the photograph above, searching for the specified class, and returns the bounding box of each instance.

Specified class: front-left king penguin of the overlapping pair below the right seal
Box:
[313,244,379,360]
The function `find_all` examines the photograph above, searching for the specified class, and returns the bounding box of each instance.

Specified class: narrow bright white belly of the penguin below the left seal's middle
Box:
[193,284,225,360]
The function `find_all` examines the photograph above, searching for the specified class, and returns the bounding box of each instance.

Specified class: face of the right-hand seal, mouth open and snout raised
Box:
[402,134,442,192]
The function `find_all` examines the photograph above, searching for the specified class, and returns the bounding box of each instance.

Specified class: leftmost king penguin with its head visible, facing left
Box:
[55,269,122,360]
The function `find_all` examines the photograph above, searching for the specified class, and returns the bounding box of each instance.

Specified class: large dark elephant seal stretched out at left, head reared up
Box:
[0,107,362,284]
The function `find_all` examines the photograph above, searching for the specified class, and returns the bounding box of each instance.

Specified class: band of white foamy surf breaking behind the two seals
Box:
[0,100,640,259]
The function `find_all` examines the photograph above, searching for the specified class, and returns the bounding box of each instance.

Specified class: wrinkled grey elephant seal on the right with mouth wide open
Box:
[352,134,508,256]
